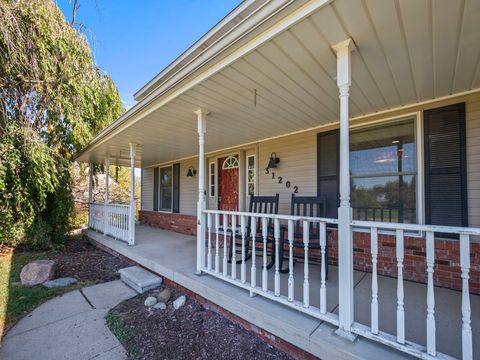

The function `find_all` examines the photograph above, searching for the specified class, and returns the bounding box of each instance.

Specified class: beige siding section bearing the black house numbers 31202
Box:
[257,131,317,214]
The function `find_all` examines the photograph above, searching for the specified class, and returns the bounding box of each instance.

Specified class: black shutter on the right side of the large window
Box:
[423,103,468,226]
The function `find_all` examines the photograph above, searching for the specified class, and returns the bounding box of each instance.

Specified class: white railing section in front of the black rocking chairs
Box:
[203,210,338,326]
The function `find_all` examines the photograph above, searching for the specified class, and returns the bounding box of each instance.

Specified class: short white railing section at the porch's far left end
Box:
[88,203,131,242]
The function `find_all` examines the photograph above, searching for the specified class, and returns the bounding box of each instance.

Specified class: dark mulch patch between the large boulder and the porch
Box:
[50,236,133,282]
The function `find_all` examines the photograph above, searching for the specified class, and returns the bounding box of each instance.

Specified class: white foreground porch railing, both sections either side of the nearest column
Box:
[202,210,480,359]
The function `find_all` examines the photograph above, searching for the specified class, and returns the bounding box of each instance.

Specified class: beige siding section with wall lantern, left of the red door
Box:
[180,158,198,215]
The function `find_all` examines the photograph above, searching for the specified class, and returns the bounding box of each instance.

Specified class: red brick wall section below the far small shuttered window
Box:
[138,210,197,235]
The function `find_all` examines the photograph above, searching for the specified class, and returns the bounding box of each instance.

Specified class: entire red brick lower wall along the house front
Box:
[139,211,480,294]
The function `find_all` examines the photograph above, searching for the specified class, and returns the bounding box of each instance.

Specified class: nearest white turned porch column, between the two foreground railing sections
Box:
[333,39,354,338]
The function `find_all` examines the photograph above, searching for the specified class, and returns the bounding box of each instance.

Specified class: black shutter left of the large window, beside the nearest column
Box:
[317,130,340,219]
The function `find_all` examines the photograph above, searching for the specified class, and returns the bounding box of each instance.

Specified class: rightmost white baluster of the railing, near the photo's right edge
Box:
[460,235,473,360]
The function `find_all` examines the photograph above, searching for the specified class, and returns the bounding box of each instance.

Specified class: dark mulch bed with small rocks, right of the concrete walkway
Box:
[109,288,293,360]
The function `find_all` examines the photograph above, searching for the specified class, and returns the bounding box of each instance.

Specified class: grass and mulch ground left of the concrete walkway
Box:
[0,235,130,339]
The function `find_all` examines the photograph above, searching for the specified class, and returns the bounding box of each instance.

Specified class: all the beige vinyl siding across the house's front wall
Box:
[136,94,480,227]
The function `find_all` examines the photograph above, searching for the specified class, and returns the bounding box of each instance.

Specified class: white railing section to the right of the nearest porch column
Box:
[352,221,480,359]
